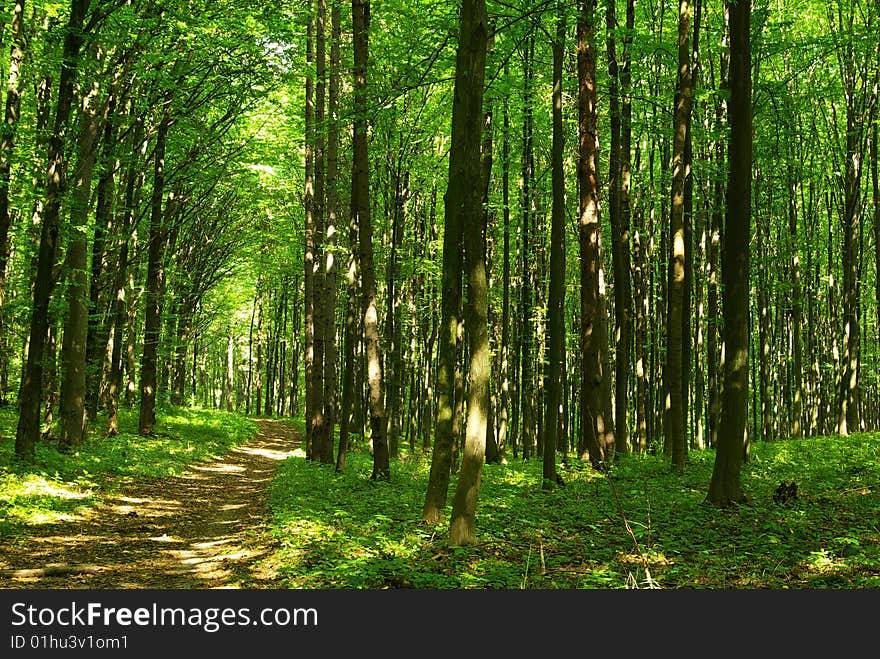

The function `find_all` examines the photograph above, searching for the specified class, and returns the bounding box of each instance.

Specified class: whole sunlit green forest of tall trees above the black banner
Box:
[0,0,880,588]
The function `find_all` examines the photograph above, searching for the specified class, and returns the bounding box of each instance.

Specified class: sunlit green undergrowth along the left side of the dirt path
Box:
[0,406,256,537]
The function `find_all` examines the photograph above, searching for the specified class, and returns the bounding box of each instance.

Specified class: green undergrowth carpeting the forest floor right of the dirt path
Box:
[268,434,880,589]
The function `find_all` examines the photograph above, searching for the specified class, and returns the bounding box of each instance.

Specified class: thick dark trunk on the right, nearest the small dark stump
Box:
[708,2,752,506]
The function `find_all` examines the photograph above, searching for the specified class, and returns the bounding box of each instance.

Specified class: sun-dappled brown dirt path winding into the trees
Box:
[0,419,299,589]
